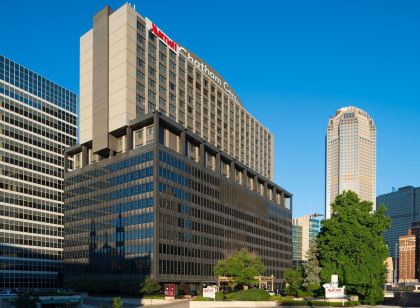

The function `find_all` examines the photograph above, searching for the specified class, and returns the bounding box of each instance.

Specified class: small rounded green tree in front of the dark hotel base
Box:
[214,249,265,287]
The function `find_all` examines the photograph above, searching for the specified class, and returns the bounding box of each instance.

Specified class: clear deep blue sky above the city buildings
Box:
[0,0,420,217]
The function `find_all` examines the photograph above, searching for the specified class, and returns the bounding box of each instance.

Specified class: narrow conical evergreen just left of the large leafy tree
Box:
[302,242,321,291]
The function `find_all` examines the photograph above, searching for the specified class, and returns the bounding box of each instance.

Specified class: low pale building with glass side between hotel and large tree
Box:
[292,213,321,261]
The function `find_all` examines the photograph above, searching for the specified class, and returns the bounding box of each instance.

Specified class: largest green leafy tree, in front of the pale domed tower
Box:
[317,191,390,304]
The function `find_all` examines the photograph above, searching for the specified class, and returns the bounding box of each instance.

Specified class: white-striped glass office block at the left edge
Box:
[0,55,77,289]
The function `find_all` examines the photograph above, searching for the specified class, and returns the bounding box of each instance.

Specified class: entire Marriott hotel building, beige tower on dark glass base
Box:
[64,4,292,283]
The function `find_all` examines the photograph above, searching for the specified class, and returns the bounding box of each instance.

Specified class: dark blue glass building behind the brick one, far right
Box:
[376,186,420,258]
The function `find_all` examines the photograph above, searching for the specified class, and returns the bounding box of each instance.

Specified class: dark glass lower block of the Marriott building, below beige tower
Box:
[64,113,292,284]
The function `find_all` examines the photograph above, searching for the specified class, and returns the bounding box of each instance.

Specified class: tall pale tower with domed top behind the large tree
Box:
[325,107,376,219]
